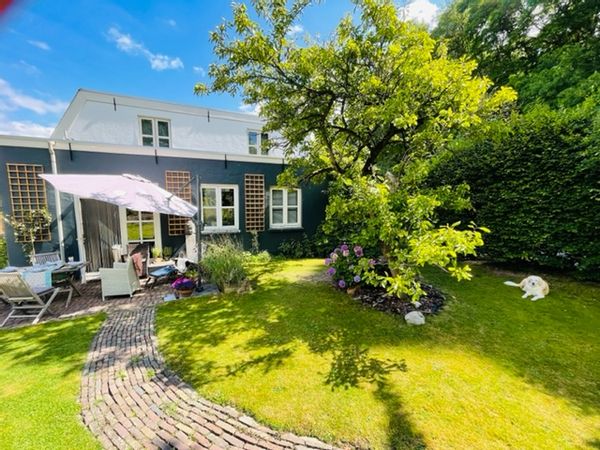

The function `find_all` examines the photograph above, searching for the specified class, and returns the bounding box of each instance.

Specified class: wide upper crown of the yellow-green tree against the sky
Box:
[196,0,515,185]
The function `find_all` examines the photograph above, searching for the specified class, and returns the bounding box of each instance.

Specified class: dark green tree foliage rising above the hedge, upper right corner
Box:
[434,0,600,107]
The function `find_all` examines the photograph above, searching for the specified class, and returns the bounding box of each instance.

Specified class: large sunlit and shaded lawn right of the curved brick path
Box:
[157,260,600,449]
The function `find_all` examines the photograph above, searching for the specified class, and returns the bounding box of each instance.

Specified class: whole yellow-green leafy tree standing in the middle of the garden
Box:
[196,0,515,299]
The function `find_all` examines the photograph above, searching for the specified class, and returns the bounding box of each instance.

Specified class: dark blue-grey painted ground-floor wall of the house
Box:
[0,145,326,265]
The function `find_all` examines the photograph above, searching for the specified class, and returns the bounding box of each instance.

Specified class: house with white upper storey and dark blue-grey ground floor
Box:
[0,89,325,271]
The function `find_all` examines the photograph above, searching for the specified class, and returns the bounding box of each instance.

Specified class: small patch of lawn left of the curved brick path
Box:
[0,315,102,450]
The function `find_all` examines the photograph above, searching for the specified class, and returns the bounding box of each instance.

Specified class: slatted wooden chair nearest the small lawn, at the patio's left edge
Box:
[0,272,61,328]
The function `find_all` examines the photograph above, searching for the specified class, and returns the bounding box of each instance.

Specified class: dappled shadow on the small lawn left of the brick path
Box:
[0,314,104,376]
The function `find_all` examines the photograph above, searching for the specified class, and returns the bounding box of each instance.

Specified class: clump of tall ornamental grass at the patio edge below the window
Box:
[202,236,246,292]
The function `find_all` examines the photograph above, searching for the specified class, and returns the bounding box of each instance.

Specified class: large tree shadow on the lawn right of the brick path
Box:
[162,268,600,448]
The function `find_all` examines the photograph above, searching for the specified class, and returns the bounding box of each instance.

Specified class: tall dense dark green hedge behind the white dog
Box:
[430,107,600,279]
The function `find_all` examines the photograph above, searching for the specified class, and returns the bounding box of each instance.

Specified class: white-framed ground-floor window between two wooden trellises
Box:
[202,184,239,232]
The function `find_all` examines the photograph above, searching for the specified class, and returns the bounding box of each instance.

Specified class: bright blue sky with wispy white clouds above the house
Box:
[0,0,445,137]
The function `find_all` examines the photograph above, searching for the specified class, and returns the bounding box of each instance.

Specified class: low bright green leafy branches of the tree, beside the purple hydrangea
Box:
[324,177,487,301]
